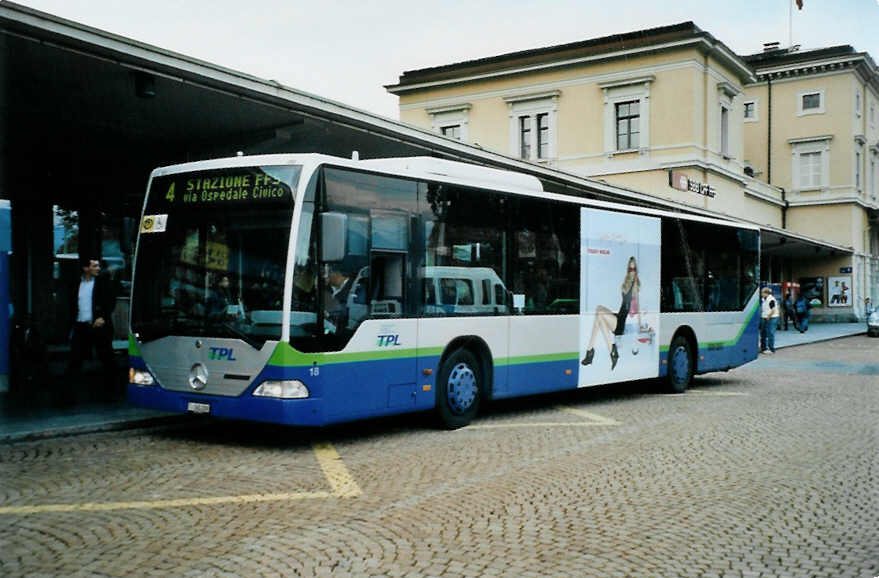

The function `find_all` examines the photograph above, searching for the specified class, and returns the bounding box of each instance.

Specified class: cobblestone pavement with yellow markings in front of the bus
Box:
[0,336,879,577]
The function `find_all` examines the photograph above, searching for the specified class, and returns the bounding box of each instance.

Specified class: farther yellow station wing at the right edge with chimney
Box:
[743,44,879,319]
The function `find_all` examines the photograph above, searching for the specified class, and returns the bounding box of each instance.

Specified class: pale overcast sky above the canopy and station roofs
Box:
[6,0,879,119]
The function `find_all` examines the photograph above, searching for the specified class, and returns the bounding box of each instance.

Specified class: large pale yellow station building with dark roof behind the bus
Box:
[386,22,879,321]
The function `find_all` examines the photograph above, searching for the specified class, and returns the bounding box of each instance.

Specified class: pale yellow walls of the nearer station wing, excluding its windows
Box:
[400,40,781,224]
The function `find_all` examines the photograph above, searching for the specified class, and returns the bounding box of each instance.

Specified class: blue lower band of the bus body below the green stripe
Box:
[128,315,759,426]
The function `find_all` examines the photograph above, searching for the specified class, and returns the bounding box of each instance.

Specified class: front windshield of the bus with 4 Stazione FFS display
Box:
[131,166,300,348]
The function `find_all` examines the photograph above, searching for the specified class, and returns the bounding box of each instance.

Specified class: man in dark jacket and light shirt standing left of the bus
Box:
[67,258,117,391]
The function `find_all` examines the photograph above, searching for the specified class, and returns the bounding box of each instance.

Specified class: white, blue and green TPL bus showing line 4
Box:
[128,154,760,428]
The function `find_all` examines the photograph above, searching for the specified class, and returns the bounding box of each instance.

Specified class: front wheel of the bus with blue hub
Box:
[436,349,482,429]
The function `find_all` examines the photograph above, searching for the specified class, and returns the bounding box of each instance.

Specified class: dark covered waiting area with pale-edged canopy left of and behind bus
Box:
[0,1,736,400]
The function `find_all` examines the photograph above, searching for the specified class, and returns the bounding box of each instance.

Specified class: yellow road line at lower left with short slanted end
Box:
[0,442,360,515]
